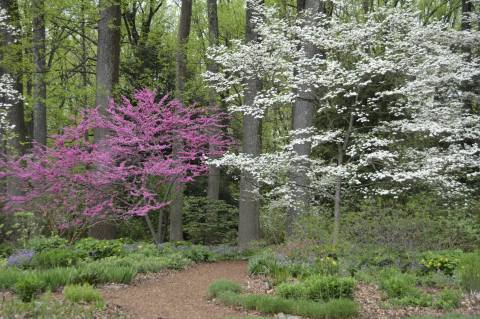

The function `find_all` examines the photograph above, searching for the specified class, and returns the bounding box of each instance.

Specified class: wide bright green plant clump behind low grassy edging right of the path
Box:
[277,275,355,301]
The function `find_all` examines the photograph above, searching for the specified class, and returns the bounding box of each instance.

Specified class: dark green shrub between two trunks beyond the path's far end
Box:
[183,196,238,245]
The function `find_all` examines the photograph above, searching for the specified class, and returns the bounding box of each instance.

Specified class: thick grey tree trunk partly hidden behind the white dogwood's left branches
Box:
[286,0,323,237]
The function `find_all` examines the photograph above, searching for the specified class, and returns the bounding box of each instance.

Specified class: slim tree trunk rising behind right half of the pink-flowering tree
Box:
[170,0,192,241]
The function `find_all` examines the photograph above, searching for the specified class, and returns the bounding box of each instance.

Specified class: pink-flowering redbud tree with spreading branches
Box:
[0,89,231,241]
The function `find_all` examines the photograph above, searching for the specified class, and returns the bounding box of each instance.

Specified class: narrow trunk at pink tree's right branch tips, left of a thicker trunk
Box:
[207,0,220,200]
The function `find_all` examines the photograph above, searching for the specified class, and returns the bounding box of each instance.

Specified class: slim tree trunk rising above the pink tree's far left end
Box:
[32,0,47,145]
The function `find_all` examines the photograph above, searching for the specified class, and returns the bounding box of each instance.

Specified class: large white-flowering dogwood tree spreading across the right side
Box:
[205,4,480,241]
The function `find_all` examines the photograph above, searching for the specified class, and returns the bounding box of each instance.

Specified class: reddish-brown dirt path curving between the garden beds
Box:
[103,261,247,319]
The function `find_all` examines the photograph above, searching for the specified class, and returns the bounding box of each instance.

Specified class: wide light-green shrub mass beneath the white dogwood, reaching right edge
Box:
[341,200,480,251]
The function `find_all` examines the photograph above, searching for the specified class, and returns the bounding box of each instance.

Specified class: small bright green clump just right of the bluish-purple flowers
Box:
[32,248,80,268]
